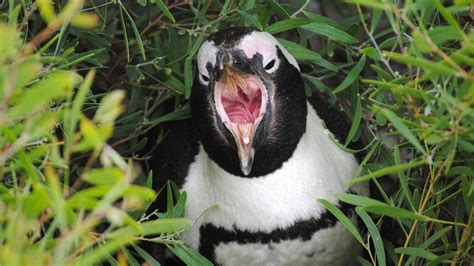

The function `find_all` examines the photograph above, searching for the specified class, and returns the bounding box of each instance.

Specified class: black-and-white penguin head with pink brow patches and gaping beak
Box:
[191,27,306,176]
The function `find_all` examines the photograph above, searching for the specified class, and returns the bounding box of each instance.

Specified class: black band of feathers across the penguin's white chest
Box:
[199,202,354,261]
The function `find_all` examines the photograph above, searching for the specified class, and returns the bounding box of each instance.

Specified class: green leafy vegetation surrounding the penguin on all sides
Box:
[0,0,474,265]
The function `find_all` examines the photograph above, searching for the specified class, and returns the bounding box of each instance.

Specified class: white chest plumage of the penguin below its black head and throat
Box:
[182,103,364,264]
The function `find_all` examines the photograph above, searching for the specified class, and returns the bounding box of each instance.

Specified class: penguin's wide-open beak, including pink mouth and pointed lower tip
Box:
[214,64,267,175]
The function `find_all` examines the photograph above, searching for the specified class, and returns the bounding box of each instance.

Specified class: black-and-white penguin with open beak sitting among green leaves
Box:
[146,27,368,265]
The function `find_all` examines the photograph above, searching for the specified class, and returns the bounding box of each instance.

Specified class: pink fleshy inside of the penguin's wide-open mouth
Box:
[215,76,266,125]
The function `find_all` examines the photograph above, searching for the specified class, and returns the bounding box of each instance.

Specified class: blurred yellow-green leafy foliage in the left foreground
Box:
[0,1,194,265]
